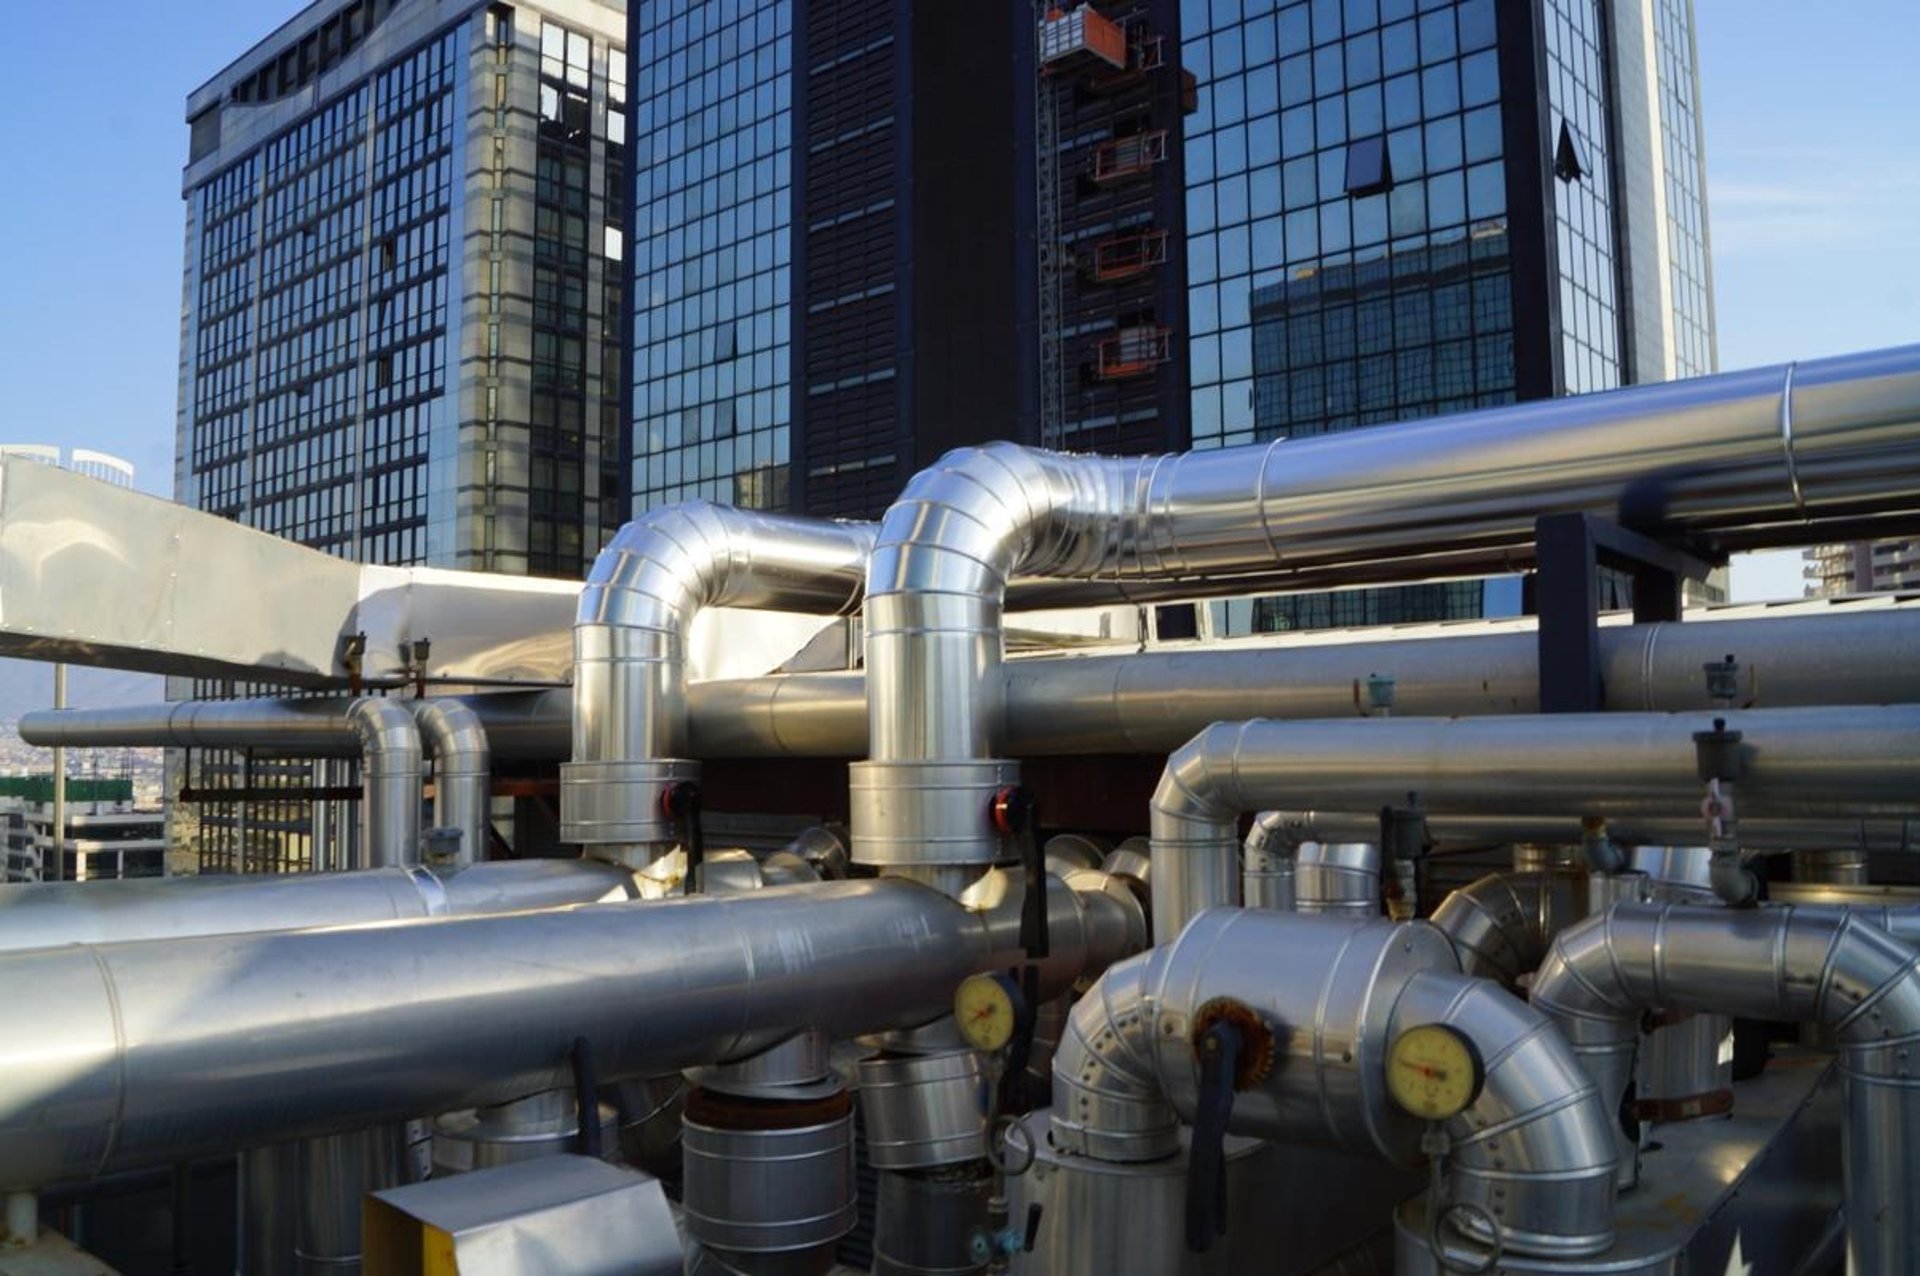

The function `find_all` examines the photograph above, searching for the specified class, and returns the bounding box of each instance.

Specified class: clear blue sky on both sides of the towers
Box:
[0,0,1920,675]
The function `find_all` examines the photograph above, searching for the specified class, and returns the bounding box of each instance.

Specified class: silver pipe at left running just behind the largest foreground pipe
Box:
[0,860,639,952]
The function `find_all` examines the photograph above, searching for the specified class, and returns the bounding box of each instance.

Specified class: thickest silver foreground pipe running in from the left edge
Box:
[0,881,1127,1190]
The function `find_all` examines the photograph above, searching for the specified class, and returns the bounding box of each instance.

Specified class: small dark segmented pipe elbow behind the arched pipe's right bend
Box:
[1432,869,1588,988]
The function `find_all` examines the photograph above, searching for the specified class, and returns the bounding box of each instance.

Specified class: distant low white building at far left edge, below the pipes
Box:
[0,775,167,883]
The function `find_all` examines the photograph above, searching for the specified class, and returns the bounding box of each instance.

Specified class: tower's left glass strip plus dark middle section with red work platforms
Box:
[630,0,1187,516]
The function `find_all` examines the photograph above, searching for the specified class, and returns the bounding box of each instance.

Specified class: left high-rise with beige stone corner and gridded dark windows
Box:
[175,0,628,871]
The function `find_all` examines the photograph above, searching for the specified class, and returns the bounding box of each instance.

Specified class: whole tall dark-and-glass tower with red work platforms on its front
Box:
[628,0,1715,627]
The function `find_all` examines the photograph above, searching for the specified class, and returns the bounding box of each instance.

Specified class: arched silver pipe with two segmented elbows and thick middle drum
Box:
[1052,910,1615,1257]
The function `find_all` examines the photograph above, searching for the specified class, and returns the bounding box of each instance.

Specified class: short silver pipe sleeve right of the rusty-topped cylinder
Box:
[854,1050,987,1170]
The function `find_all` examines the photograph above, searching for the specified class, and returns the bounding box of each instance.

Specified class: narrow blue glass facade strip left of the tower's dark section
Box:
[628,0,793,508]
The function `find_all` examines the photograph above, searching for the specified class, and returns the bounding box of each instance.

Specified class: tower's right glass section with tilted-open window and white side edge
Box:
[1181,0,1715,627]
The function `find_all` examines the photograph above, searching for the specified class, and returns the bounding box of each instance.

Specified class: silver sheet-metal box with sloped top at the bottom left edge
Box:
[367,1157,684,1276]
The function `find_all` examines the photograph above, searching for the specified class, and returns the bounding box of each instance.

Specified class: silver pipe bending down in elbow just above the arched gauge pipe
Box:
[1150,706,1920,942]
